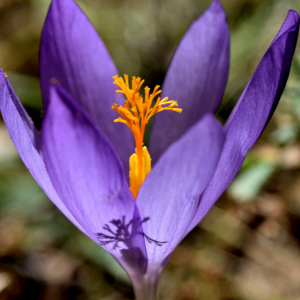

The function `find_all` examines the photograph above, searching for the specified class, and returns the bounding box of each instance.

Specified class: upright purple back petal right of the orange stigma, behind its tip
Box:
[150,0,229,163]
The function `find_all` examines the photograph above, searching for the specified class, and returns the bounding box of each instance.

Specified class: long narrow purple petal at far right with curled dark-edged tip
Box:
[187,11,299,232]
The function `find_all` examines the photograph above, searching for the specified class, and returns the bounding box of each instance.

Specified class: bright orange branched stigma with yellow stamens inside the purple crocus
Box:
[112,75,182,199]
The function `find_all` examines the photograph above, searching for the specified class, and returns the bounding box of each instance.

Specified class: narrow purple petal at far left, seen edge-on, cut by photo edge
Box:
[0,70,86,233]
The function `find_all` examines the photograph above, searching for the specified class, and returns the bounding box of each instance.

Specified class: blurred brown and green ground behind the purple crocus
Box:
[0,0,300,300]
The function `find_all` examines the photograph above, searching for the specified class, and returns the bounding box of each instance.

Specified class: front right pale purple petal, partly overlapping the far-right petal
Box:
[137,114,224,268]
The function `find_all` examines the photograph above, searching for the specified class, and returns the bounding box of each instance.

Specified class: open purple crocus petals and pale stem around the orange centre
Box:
[0,0,299,299]
